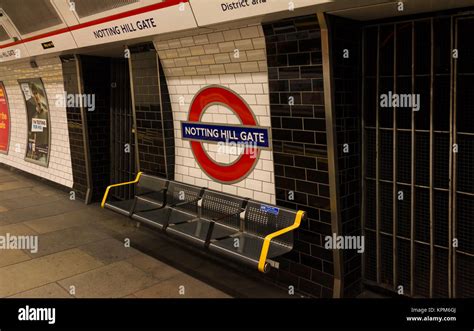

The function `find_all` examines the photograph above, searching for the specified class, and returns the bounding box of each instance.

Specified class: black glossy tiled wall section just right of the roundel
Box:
[263,15,334,297]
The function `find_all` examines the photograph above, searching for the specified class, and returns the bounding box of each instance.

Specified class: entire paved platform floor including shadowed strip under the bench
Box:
[0,167,295,298]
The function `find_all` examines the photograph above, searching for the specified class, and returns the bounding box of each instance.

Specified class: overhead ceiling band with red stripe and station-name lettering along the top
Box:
[0,0,474,62]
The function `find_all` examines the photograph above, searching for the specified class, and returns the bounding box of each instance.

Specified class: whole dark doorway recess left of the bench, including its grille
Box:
[80,56,136,202]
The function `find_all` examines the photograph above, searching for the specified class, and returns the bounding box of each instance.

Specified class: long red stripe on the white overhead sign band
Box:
[0,0,189,49]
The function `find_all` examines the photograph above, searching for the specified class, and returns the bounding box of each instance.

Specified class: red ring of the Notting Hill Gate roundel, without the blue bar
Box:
[188,86,257,183]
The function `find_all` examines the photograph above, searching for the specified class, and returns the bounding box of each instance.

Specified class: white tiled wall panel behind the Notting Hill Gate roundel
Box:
[155,25,275,203]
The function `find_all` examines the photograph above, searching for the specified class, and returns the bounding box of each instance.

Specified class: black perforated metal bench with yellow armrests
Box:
[102,173,305,272]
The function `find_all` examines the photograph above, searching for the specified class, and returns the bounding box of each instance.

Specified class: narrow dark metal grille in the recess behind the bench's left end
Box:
[110,59,136,200]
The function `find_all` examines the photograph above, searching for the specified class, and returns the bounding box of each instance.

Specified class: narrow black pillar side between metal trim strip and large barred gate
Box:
[328,16,367,297]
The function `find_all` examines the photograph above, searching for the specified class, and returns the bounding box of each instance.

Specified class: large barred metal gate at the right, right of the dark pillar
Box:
[362,15,474,297]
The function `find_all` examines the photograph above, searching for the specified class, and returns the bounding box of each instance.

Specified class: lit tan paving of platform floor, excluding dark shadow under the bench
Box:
[0,168,230,298]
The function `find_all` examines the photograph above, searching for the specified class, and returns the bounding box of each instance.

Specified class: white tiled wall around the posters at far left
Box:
[0,58,73,187]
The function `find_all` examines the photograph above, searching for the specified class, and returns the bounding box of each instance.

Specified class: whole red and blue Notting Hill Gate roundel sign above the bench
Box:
[181,85,271,184]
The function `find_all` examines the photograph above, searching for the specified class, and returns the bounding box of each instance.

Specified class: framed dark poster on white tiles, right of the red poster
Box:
[18,78,51,167]
